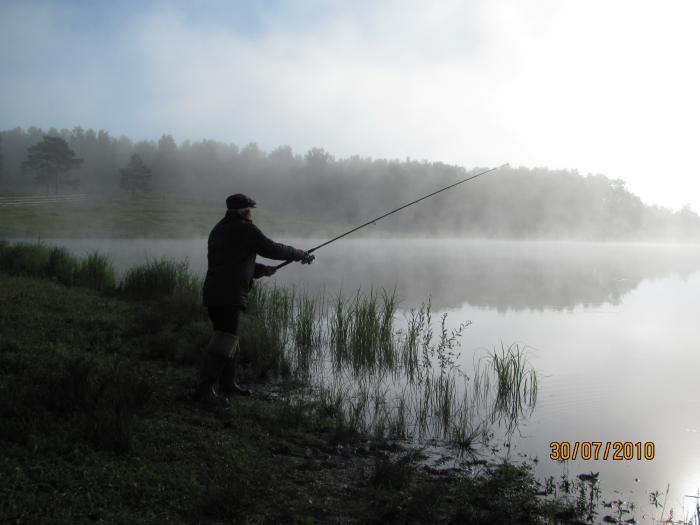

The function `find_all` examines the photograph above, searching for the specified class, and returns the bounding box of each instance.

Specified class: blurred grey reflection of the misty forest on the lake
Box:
[34,239,700,312]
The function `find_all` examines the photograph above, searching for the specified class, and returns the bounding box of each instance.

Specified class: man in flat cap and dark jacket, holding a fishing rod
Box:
[195,193,314,405]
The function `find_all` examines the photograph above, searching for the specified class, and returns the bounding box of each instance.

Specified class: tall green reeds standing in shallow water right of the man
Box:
[244,278,537,452]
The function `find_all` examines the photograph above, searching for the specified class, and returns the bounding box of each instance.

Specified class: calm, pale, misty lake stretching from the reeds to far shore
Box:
[41,239,700,521]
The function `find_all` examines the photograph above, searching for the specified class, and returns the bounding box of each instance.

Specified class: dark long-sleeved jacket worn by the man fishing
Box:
[202,211,304,308]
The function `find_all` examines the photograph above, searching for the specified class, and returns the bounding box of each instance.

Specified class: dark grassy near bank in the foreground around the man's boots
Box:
[0,241,593,523]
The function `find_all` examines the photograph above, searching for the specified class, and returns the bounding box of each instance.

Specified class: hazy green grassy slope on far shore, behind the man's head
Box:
[0,195,347,238]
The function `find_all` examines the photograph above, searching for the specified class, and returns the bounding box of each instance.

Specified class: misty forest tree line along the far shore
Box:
[0,127,700,240]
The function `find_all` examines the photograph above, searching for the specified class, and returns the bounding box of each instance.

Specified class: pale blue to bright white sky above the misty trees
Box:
[0,0,700,212]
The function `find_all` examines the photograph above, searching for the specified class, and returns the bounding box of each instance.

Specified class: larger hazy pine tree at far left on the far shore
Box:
[22,135,83,193]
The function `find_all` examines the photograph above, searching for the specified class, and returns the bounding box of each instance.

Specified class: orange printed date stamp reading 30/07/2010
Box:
[549,441,656,461]
